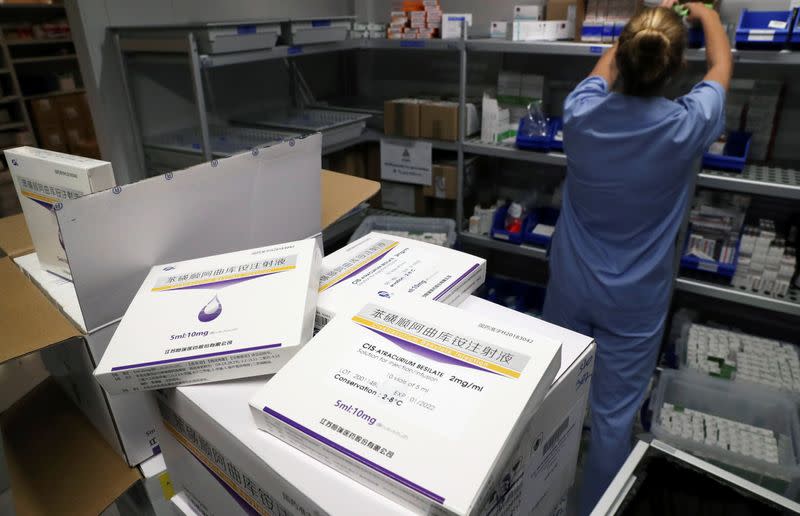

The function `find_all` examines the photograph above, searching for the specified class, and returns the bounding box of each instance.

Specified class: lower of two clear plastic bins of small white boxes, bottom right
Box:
[650,370,800,494]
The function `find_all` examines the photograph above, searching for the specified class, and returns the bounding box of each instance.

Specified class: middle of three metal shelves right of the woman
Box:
[697,165,800,204]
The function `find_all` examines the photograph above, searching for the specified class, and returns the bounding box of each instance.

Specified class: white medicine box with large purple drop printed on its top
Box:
[95,239,321,394]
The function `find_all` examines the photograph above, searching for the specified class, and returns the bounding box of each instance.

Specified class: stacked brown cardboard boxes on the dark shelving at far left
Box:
[30,93,100,159]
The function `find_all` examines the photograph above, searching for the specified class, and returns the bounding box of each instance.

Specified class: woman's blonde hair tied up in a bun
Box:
[616,7,686,97]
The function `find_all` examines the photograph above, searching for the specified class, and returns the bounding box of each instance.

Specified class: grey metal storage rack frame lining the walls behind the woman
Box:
[112,27,800,317]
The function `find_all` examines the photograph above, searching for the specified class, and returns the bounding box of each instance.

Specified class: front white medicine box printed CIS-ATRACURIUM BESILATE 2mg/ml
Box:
[250,296,561,515]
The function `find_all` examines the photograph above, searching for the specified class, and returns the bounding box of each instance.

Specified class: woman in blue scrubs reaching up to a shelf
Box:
[544,0,733,514]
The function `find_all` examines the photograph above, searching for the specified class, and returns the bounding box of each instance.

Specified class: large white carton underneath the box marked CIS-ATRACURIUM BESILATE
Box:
[159,297,594,516]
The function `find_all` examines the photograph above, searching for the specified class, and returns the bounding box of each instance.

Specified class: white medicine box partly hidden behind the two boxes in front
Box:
[315,232,486,329]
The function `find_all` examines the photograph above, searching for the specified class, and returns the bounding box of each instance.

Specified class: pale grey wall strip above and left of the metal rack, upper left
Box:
[66,0,354,183]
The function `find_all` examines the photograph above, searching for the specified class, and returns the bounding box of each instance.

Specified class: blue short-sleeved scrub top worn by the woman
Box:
[551,76,725,316]
